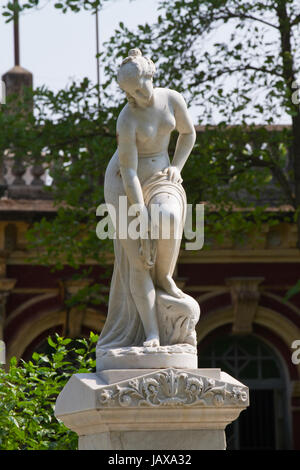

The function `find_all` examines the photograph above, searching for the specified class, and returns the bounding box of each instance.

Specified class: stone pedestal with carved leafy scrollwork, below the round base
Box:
[55,368,249,450]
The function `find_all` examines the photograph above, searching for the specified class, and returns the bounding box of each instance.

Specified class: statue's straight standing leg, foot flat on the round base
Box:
[120,238,159,347]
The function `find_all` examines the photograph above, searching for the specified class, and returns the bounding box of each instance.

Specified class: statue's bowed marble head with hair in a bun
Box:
[117,49,155,106]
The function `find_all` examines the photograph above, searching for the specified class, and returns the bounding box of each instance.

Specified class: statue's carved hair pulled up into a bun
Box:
[117,48,156,106]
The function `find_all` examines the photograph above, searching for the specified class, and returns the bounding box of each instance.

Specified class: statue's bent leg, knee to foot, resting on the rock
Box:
[150,193,184,298]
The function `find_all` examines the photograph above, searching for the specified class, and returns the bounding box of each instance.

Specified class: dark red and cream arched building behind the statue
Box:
[0,70,300,449]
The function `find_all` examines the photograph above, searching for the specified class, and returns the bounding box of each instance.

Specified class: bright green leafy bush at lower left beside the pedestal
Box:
[0,332,98,450]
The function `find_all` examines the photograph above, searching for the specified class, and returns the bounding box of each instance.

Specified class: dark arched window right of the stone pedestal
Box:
[199,335,290,450]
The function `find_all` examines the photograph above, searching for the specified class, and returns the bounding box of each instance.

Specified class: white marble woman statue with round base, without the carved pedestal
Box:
[97,49,200,370]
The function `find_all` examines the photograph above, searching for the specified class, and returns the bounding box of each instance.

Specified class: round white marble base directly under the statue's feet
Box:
[96,344,198,372]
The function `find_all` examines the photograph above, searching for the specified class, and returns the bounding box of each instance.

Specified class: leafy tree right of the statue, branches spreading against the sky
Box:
[102,0,300,242]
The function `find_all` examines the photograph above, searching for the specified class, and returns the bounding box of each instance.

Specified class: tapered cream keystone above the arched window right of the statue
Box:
[226,277,264,334]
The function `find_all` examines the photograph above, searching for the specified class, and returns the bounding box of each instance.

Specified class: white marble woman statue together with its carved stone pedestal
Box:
[55,63,249,448]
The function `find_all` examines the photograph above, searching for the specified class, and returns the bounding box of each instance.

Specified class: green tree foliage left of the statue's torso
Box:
[0,79,118,269]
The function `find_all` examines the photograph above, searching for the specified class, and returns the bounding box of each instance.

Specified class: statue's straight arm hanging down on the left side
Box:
[117,112,144,207]
